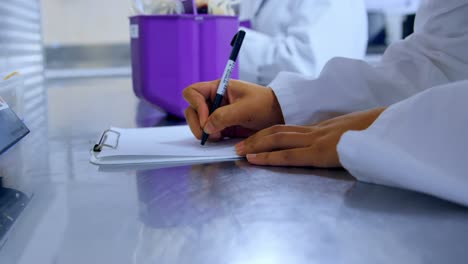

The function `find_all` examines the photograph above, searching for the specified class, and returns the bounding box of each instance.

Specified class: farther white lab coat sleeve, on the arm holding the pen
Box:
[270,0,468,124]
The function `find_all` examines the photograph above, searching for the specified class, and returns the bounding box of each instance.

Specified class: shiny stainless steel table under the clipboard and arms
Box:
[0,79,468,264]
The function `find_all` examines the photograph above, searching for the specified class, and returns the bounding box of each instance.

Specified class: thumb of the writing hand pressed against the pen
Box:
[203,103,243,134]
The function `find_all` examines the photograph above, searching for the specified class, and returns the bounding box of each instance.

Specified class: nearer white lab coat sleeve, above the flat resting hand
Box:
[338,81,468,206]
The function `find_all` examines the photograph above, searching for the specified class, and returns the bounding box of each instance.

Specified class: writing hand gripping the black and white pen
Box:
[183,80,284,140]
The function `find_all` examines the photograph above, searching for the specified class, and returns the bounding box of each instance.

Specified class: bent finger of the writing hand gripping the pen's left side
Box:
[183,82,217,127]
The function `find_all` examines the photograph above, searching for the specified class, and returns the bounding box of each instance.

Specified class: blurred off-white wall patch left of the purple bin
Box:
[42,0,130,45]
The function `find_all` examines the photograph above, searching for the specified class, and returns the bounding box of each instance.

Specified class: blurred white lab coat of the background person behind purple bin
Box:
[239,0,368,84]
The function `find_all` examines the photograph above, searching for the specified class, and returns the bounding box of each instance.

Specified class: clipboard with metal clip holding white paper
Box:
[90,125,242,166]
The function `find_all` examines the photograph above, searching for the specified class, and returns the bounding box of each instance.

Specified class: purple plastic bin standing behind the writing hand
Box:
[130,15,239,117]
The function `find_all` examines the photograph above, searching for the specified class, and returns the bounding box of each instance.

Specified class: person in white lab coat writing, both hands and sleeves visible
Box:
[184,0,468,206]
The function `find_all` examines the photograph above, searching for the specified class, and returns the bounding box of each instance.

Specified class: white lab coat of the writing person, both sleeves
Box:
[270,0,468,206]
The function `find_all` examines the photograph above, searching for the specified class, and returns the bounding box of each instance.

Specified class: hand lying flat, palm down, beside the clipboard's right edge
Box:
[236,108,385,168]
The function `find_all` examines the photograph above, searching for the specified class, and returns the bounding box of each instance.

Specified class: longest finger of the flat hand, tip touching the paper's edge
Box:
[236,132,314,156]
